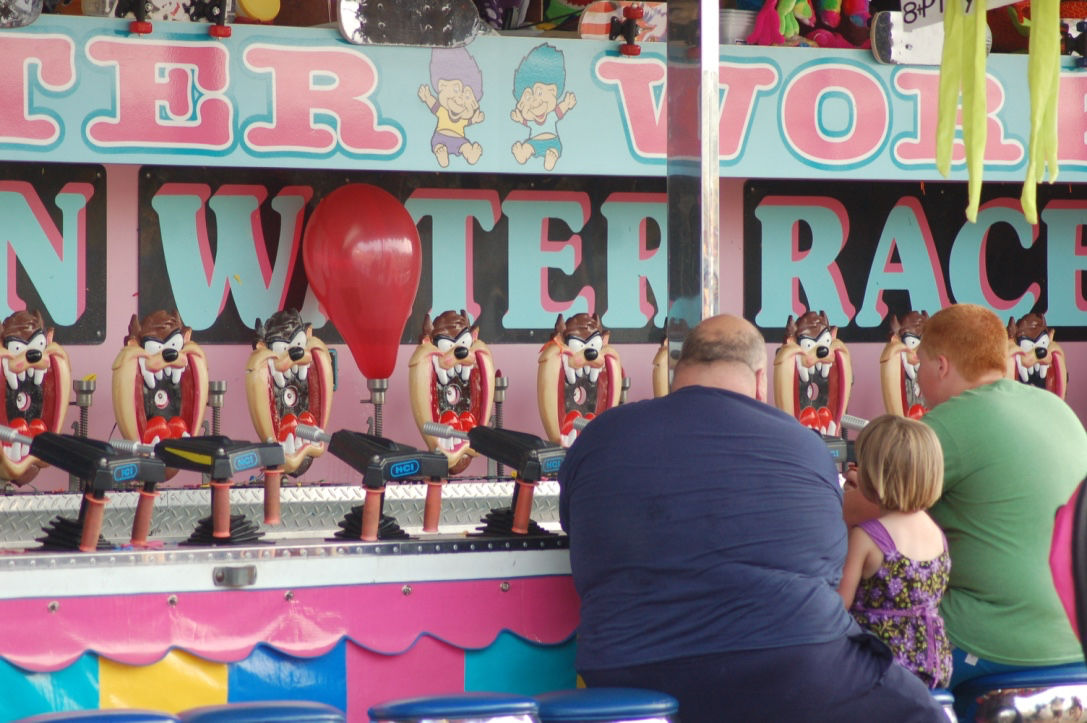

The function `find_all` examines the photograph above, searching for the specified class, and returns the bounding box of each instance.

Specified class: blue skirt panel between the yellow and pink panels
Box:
[227,640,347,710]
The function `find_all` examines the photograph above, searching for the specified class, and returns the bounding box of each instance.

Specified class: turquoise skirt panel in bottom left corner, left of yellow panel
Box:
[0,652,98,721]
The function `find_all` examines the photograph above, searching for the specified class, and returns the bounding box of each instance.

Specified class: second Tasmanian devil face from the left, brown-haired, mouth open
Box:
[113,311,208,445]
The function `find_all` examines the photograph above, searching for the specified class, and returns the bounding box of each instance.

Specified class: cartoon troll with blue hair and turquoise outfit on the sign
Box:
[510,43,577,171]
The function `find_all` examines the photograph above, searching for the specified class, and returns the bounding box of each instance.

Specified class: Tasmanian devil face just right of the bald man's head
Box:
[774,311,853,435]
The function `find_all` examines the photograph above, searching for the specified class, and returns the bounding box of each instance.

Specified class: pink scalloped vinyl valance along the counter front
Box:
[0,575,577,671]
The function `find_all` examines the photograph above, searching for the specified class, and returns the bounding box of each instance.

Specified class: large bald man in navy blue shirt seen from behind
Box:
[559,315,947,723]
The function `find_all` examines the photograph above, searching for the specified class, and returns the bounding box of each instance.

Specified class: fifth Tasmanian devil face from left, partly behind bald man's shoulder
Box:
[536,313,623,447]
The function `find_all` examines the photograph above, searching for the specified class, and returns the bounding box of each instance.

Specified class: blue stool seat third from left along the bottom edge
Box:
[370,691,539,723]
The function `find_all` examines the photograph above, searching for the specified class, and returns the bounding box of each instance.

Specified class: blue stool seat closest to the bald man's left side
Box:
[536,688,679,723]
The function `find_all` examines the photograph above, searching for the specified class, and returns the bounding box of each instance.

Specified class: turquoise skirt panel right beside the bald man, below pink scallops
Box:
[464,632,577,696]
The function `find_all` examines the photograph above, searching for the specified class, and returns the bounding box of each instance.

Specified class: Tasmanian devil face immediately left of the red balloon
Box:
[246,309,333,474]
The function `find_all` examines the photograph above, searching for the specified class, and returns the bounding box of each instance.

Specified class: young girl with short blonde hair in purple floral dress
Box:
[838,414,951,688]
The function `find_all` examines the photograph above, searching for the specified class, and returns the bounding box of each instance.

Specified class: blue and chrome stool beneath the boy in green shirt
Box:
[954,663,1087,723]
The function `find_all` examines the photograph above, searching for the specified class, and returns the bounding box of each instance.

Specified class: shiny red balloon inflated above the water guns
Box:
[302,184,423,379]
